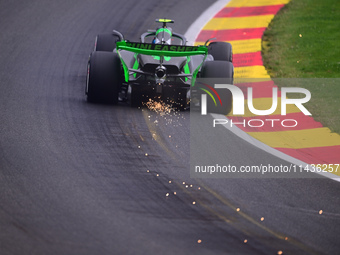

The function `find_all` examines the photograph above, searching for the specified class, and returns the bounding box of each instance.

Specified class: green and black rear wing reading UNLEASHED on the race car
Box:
[116,41,208,81]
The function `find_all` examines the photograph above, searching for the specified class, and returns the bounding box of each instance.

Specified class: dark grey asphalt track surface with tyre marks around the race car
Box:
[0,0,340,254]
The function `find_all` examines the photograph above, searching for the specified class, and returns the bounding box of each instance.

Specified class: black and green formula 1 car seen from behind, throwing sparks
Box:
[85,19,234,113]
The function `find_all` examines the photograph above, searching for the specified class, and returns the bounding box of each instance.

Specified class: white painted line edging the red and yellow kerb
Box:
[185,0,340,182]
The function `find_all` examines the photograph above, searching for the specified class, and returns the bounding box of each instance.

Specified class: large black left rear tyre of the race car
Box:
[86,51,122,104]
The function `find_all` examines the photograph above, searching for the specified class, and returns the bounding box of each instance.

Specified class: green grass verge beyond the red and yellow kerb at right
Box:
[262,0,340,133]
